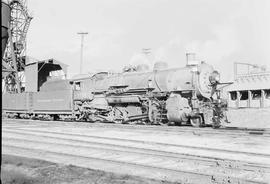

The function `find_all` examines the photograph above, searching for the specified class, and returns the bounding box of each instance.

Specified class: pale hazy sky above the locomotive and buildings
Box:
[27,0,270,81]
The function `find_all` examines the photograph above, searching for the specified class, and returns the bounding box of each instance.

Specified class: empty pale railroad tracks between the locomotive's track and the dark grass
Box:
[3,124,270,183]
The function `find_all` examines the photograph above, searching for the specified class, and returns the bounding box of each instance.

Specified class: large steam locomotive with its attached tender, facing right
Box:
[2,60,227,128]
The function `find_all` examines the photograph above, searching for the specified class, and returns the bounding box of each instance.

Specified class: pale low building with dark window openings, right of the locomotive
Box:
[225,63,270,108]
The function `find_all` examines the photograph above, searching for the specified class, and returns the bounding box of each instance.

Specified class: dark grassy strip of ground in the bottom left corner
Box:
[1,155,177,184]
